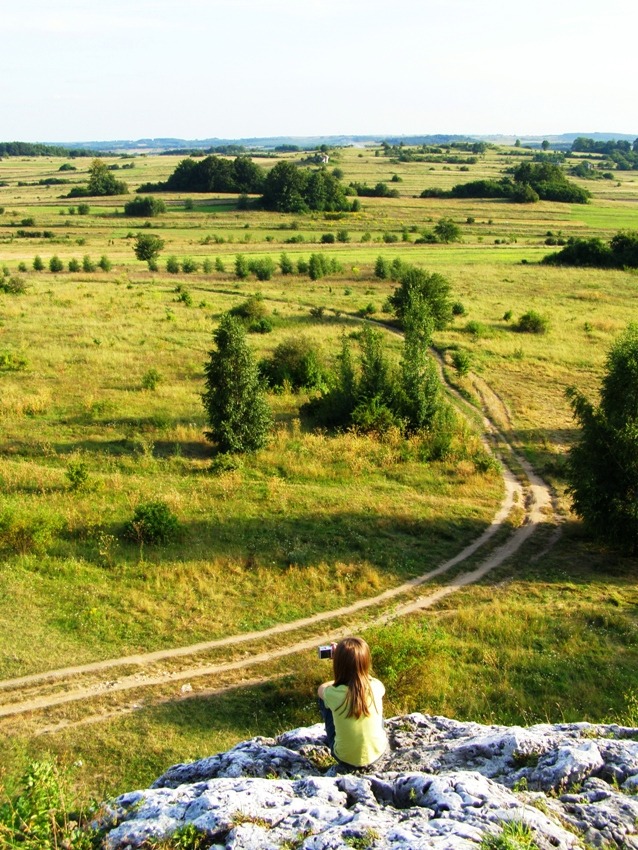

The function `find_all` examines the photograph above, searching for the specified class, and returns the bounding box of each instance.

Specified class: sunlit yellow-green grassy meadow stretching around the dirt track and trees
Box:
[0,148,638,796]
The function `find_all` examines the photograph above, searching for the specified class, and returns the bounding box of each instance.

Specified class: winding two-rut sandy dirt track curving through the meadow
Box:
[0,342,557,734]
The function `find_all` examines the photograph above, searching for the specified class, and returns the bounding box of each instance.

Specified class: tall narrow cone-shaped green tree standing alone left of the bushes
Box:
[202,313,272,453]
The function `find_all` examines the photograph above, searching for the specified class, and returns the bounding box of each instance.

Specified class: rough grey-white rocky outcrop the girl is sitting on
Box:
[95,714,638,850]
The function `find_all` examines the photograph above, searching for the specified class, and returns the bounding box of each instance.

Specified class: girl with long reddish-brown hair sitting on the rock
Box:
[317,637,388,768]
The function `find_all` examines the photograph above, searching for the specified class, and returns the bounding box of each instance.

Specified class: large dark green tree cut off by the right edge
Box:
[567,324,638,555]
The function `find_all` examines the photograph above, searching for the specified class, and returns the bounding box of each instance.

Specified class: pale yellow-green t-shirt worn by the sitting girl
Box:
[323,679,388,767]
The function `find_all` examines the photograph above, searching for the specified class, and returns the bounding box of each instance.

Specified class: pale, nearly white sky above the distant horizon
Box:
[0,0,638,141]
